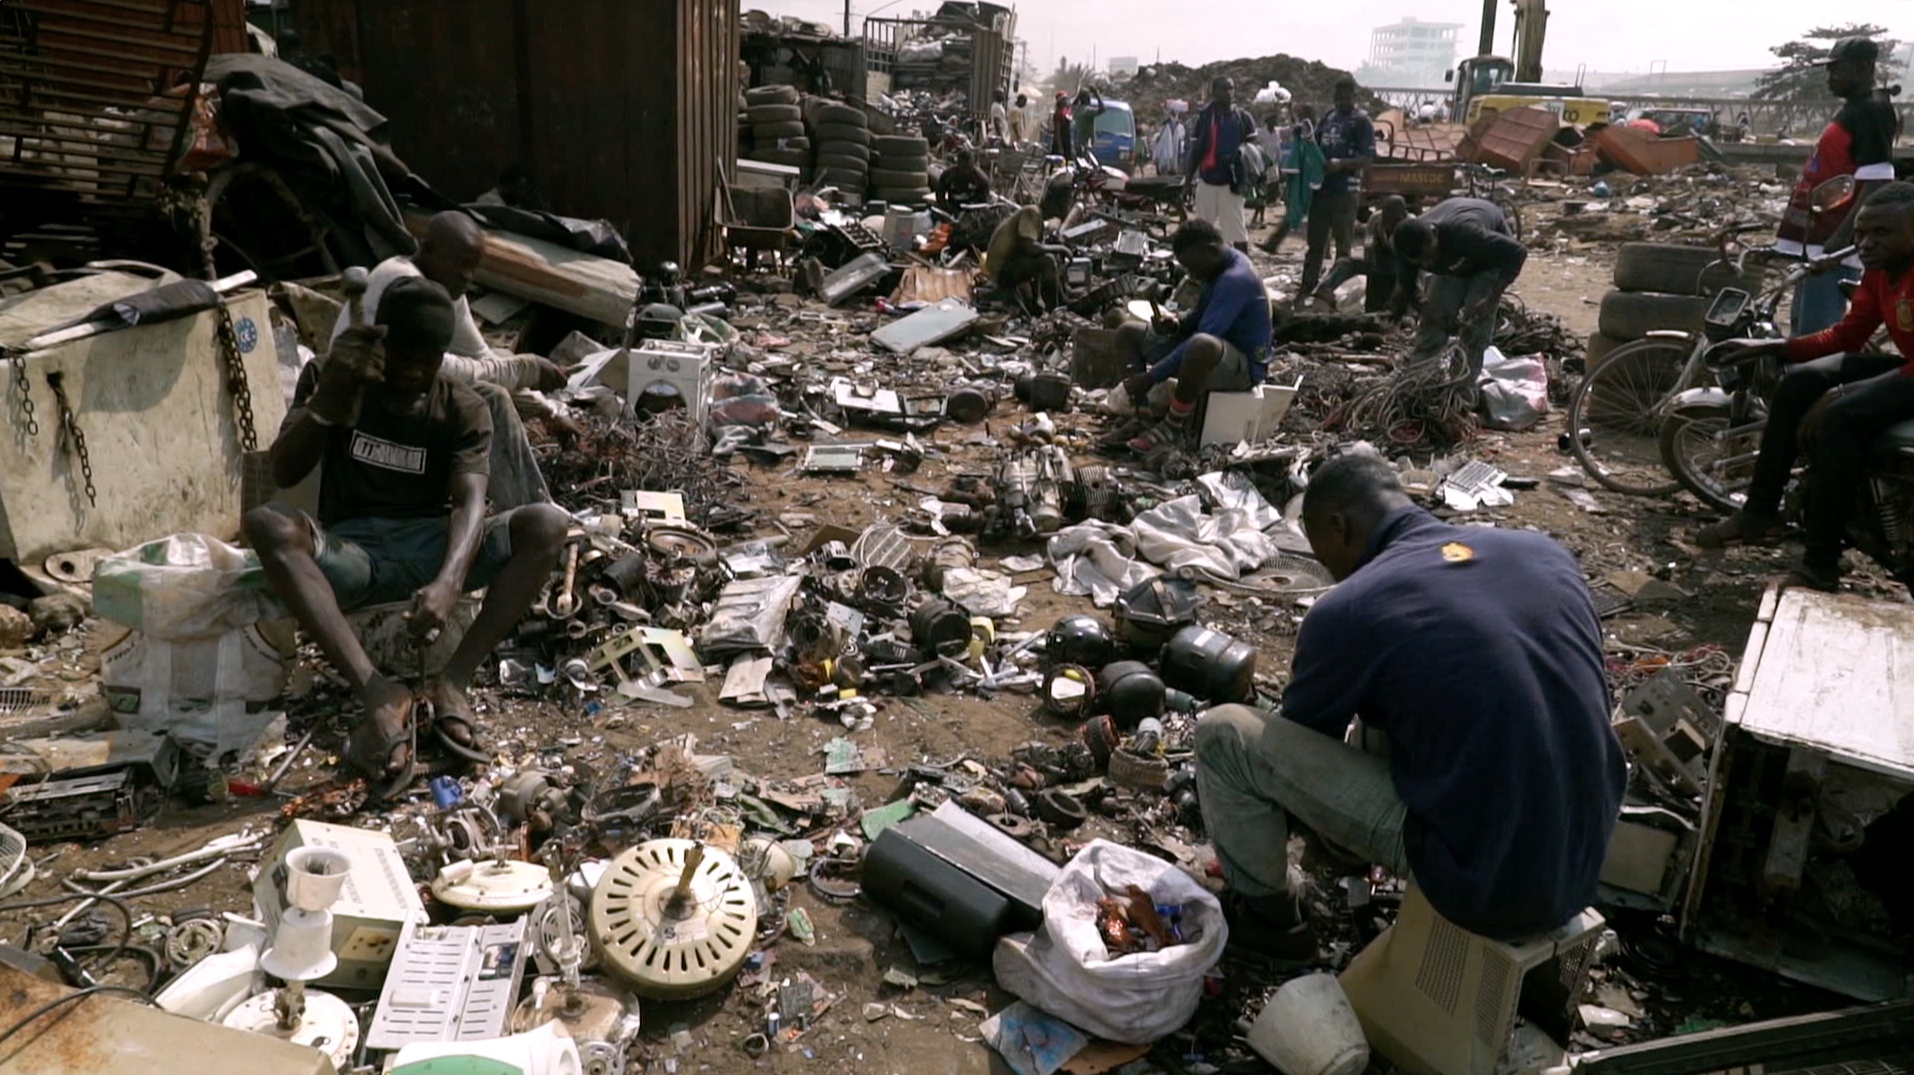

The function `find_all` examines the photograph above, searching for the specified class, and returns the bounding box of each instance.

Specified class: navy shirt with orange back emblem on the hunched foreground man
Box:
[1282,507,1627,939]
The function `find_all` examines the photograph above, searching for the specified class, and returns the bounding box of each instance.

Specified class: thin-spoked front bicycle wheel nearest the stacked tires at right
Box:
[1568,339,1692,497]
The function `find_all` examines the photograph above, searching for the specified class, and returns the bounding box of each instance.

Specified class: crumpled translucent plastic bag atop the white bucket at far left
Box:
[94,534,285,641]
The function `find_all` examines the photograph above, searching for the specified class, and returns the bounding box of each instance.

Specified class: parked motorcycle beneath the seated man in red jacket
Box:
[1661,251,1914,587]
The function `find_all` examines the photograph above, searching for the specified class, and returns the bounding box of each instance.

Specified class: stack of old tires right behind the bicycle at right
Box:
[1589,243,1761,369]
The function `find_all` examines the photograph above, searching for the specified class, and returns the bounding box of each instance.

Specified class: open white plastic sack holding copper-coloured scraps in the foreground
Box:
[991,840,1229,1044]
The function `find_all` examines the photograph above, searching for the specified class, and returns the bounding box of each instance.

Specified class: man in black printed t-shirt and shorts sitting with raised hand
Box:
[245,277,570,798]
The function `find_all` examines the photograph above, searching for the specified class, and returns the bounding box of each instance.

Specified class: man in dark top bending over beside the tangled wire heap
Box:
[1390,197,1529,373]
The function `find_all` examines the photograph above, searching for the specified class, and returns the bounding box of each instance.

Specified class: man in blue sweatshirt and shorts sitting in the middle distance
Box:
[1120,220,1271,451]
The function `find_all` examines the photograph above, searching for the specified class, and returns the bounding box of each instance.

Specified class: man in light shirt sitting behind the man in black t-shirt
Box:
[333,210,565,507]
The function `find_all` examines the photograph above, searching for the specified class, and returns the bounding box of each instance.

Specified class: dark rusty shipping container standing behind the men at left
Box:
[295,0,741,268]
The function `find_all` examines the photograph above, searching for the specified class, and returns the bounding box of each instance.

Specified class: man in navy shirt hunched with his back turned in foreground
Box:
[1196,451,1627,960]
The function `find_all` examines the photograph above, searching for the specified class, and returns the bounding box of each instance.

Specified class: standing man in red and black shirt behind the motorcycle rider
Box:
[1774,38,1895,337]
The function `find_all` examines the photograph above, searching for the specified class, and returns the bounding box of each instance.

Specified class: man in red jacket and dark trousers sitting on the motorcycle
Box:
[1696,182,1914,591]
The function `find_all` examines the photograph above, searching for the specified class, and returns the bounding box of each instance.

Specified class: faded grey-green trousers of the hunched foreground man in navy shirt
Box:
[1196,706,1409,897]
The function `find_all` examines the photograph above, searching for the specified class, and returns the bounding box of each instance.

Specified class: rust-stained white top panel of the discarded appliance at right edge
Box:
[1738,589,1914,779]
